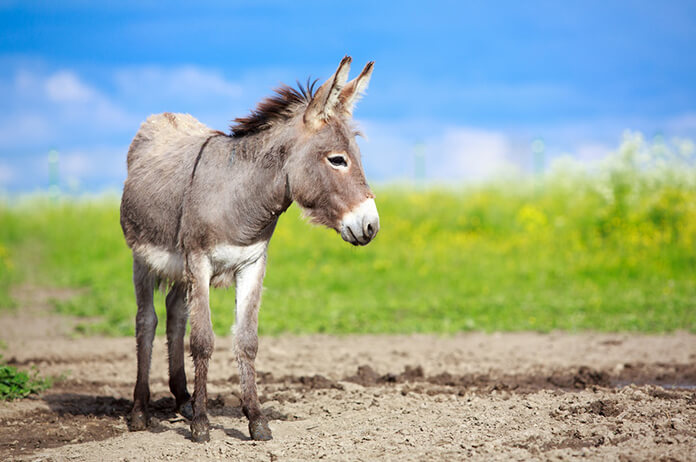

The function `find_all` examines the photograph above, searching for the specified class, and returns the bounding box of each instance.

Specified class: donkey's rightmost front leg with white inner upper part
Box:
[234,255,272,441]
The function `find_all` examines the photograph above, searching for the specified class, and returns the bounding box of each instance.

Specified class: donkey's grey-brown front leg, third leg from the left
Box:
[187,254,215,442]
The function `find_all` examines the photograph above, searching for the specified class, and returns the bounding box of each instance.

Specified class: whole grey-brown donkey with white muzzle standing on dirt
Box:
[121,56,379,442]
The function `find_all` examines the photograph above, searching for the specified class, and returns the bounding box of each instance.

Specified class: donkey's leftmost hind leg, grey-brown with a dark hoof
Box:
[129,257,157,431]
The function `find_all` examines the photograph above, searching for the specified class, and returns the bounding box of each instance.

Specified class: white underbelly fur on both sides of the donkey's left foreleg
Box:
[133,241,268,287]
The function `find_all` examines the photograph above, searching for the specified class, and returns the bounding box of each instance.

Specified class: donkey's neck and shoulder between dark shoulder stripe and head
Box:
[178,130,291,251]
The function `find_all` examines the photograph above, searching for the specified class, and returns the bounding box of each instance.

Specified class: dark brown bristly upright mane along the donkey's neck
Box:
[230,79,317,137]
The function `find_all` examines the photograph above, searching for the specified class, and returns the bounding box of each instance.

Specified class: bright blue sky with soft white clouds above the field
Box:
[0,0,696,192]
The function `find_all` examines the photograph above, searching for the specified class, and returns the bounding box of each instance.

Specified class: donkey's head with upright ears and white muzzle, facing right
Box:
[286,57,379,245]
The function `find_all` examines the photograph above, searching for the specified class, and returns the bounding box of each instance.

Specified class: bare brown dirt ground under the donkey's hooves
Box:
[0,286,696,461]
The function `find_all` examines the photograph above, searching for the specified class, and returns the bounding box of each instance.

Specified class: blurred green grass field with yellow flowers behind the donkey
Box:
[0,134,696,335]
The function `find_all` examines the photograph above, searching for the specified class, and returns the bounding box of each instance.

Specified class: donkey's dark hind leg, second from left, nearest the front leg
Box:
[166,283,193,420]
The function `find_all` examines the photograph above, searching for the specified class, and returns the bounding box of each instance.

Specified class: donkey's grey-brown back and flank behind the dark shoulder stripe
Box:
[121,112,216,251]
